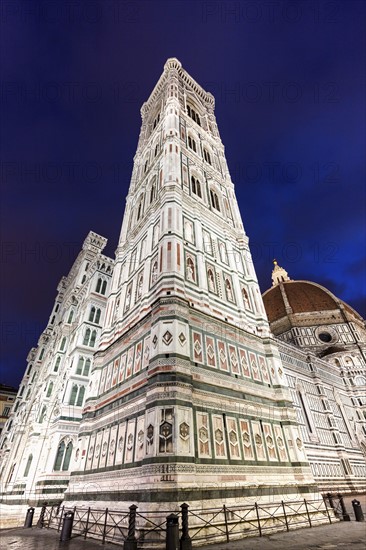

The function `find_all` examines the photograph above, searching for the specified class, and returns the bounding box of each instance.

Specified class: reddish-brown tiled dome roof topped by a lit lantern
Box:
[263,261,362,323]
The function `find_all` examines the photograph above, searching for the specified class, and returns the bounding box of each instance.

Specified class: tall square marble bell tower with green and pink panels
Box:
[65,58,315,510]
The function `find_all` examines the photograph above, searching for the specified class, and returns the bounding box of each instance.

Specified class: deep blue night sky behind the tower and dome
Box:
[0,0,366,385]
